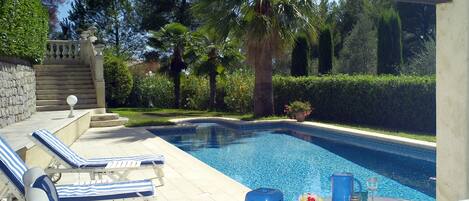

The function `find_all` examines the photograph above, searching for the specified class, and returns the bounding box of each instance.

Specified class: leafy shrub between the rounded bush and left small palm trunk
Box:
[140,74,175,108]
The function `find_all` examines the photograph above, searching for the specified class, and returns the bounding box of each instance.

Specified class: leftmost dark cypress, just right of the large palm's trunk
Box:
[290,34,310,77]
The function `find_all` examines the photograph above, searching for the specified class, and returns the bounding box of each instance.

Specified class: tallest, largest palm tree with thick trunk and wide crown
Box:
[193,0,314,117]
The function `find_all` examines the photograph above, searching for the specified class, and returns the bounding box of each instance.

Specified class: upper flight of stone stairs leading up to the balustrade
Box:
[35,65,98,111]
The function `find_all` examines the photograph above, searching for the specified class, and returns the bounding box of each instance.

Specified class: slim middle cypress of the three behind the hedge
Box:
[318,26,334,74]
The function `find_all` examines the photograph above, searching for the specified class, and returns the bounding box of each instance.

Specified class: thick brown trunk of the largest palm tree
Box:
[254,42,274,117]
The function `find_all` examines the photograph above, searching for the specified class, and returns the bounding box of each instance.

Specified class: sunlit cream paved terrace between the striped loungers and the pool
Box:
[59,127,249,201]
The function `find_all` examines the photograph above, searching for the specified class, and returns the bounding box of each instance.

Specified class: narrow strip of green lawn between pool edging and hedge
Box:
[109,108,436,142]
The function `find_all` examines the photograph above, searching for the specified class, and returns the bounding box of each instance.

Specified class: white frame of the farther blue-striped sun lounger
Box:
[29,136,164,186]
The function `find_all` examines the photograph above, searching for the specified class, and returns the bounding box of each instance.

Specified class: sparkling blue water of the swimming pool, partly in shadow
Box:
[154,124,436,201]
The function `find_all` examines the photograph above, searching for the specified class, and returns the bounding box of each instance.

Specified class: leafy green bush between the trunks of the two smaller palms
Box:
[181,76,210,110]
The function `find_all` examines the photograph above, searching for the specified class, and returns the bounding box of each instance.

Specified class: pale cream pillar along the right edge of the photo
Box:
[437,0,469,201]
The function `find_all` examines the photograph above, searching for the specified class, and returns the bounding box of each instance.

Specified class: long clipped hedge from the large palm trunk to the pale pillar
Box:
[274,75,436,133]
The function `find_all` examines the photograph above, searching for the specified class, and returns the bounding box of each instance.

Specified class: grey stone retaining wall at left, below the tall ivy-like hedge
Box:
[0,61,36,128]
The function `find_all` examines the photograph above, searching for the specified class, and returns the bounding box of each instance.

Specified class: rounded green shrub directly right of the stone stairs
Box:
[104,55,133,106]
